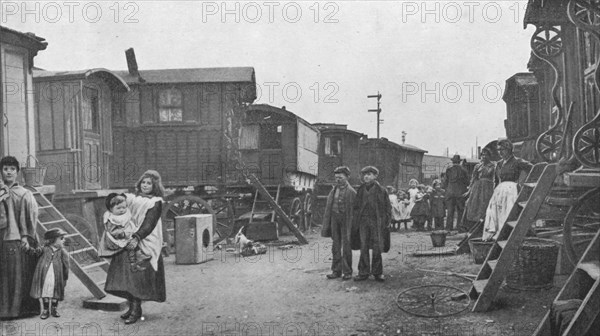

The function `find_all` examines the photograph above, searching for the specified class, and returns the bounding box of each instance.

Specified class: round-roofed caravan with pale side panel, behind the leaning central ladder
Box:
[239,105,319,234]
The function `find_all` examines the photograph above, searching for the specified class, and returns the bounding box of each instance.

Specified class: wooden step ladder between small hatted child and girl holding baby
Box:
[26,187,109,299]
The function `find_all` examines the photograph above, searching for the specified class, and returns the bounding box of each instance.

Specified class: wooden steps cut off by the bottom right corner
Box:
[533,231,600,336]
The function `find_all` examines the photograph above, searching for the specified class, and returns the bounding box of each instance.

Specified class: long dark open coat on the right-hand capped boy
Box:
[350,181,392,252]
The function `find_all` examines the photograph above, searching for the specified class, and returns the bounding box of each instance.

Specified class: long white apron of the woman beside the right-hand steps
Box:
[482,182,519,240]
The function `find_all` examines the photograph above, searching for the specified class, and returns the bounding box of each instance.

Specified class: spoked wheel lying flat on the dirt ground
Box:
[396,285,471,317]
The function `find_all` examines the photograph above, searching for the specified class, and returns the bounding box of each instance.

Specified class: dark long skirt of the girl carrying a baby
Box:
[105,250,167,302]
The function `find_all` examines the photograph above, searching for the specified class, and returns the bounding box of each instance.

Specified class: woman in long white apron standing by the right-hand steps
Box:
[482,139,533,241]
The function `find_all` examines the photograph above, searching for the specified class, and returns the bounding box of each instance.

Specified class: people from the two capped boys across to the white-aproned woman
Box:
[321,139,532,281]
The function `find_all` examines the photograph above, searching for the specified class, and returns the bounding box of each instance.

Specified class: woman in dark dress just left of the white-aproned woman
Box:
[464,148,496,231]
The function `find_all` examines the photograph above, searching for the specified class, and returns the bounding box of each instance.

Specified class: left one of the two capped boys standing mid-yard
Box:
[321,166,356,281]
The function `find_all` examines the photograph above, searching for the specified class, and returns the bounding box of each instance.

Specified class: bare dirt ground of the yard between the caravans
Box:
[0,230,564,336]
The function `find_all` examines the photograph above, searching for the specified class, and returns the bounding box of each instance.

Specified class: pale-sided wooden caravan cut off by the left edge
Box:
[0,26,48,165]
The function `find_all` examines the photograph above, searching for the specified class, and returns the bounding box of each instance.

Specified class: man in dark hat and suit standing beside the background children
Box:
[442,155,469,231]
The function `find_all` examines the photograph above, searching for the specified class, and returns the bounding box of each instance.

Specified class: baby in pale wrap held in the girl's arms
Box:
[98,193,151,272]
